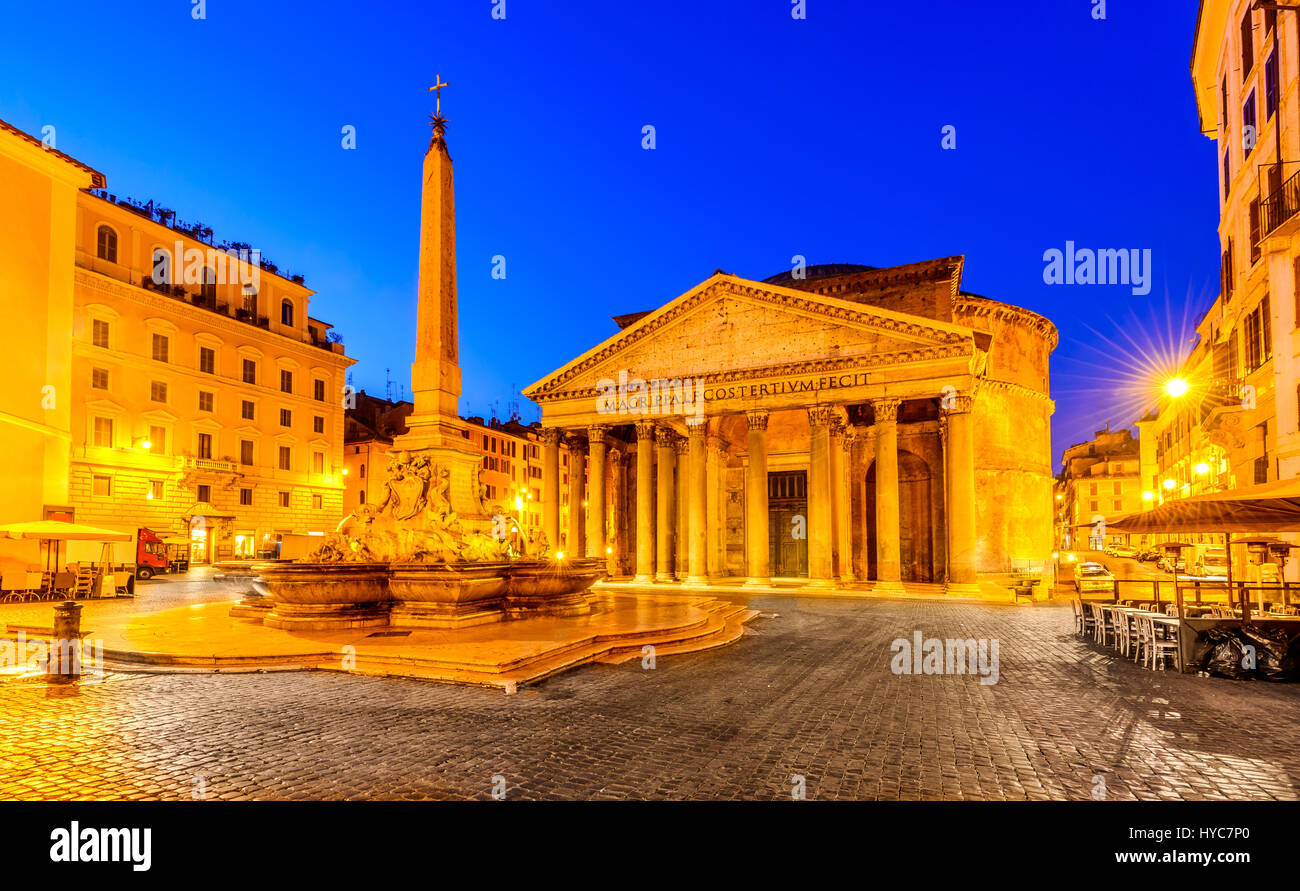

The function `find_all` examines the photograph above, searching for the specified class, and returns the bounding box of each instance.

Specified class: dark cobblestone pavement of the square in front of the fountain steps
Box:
[0,587,1300,800]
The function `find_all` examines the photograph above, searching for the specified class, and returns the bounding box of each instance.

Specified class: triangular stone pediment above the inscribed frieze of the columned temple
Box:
[524,273,974,398]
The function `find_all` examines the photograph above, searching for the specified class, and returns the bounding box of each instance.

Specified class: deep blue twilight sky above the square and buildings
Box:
[0,0,1218,462]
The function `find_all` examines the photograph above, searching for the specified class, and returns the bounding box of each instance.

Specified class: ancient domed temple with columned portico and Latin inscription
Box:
[524,256,1057,593]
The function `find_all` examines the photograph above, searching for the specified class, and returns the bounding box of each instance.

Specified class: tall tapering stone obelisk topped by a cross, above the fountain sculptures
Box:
[393,78,484,519]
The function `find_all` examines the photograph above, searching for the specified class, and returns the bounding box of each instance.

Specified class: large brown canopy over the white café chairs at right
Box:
[1106,479,1300,532]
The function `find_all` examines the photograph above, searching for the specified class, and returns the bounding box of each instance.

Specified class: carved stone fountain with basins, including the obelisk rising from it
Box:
[231,85,605,631]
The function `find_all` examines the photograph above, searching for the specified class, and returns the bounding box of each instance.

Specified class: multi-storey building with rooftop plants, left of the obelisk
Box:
[4,118,352,562]
